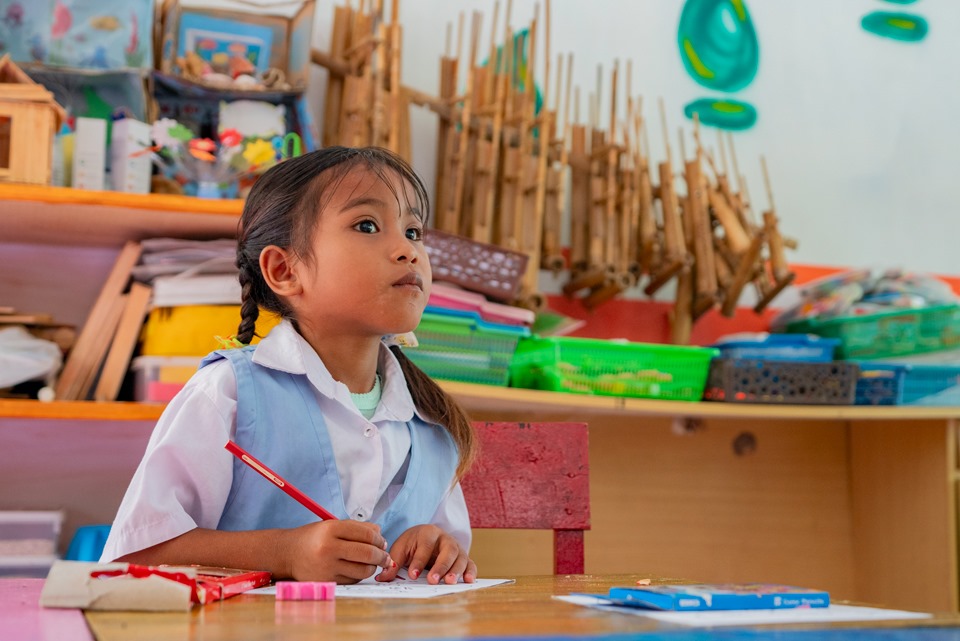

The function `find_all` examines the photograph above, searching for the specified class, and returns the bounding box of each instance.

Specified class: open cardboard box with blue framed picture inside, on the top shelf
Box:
[159,0,315,91]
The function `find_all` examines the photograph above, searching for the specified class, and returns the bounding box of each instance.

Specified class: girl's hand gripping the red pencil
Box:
[277,520,397,583]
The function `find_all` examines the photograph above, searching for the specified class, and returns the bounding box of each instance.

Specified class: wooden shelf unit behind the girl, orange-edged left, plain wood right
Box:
[0,185,960,611]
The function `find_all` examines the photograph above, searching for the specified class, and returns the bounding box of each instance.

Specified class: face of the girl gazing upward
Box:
[288,167,432,339]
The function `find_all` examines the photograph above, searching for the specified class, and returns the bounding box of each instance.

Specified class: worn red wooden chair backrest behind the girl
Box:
[461,422,590,574]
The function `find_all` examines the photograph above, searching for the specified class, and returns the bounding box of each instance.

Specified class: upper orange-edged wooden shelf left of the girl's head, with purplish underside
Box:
[0,183,243,247]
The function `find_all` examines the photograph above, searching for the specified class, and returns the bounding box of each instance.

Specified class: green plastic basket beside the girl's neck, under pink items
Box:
[403,313,522,386]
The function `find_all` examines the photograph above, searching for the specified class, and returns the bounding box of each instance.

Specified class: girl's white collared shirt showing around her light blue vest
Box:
[101,321,471,561]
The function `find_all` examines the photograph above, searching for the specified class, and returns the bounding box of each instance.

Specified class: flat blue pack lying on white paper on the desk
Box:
[607,583,830,610]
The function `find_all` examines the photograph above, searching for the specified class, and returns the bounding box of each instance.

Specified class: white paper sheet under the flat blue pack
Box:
[554,594,932,627]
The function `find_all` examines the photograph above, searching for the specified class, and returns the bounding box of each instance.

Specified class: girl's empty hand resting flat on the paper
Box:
[377,525,477,585]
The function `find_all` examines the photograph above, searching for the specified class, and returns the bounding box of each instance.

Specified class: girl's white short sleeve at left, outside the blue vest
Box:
[100,361,237,562]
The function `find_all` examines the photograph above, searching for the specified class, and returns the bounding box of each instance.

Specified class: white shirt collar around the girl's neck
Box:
[253,319,423,422]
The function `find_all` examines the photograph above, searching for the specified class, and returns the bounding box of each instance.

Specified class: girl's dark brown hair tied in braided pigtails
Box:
[237,147,476,479]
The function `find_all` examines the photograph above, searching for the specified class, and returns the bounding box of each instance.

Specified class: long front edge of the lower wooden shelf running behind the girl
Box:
[0,381,960,421]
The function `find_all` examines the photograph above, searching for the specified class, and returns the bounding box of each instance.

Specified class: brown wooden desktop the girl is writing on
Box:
[86,575,960,641]
